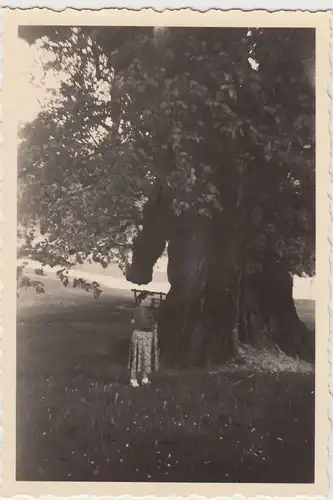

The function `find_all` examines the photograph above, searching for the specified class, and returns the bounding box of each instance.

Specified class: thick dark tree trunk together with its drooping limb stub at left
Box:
[128,199,314,366]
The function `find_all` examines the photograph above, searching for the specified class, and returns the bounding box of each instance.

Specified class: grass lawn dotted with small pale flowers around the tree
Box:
[17,280,314,482]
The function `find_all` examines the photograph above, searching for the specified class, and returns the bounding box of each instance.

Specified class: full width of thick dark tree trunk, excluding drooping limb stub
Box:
[160,232,314,366]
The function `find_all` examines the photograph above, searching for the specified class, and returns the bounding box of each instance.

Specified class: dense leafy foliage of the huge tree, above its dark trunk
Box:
[19,27,315,275]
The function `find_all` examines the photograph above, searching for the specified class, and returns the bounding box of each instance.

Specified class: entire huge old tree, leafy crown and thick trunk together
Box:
[19,27,315,365]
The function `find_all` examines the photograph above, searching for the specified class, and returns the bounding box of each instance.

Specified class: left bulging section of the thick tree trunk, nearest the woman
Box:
[160,219,237,366]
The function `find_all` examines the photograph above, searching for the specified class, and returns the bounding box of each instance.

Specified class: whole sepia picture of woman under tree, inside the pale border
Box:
[1,8,329,500]
